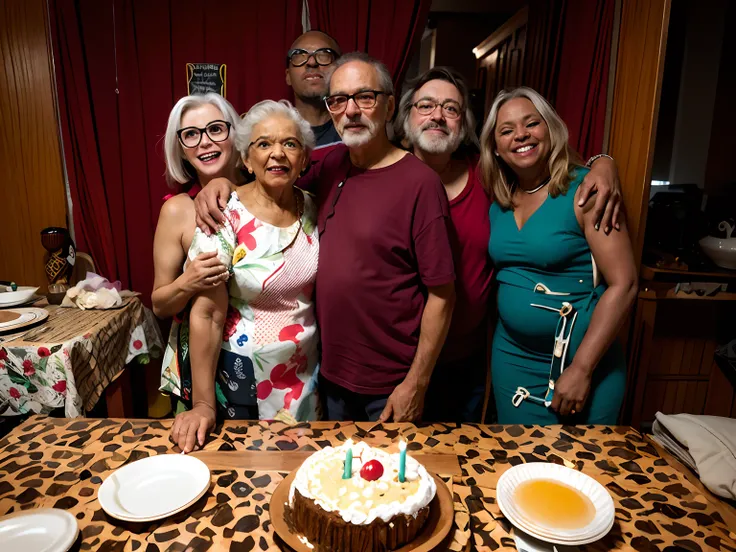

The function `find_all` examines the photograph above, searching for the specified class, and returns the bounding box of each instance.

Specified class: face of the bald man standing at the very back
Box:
[286,31,338,100]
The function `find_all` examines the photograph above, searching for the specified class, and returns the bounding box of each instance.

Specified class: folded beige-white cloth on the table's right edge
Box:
[653,412,736,500]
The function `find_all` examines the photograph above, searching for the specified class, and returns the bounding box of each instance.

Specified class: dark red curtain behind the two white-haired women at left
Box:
[50,0,302,301]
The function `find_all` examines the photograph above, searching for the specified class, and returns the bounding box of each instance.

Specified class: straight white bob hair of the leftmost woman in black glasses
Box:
[164,92,240,184]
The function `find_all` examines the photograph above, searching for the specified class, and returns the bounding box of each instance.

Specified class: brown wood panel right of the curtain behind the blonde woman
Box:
[609,0,671,265]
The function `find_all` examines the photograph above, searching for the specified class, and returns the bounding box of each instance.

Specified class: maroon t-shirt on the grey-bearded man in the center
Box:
[299,146,455,394]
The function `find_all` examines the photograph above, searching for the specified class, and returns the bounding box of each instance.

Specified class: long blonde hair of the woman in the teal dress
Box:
[480,86,583,209]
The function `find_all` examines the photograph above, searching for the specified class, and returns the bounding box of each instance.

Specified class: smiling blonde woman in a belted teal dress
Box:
[481,87,637,425]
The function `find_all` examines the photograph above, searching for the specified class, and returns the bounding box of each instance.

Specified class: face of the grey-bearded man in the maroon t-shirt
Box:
[330,61,394,148]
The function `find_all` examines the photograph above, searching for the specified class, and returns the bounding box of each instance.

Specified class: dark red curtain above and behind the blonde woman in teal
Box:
[524,0,615,157]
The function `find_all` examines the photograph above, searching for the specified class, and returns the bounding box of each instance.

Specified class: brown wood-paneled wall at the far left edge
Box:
[0,0,66,291]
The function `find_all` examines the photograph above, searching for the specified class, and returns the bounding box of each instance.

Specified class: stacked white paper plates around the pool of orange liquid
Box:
[496,462,615,546]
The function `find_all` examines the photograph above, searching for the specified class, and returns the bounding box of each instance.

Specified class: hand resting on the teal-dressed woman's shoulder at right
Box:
[578,157,623,234]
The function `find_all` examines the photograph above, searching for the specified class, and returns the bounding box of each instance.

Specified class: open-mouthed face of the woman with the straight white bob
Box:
[179,104,237,180]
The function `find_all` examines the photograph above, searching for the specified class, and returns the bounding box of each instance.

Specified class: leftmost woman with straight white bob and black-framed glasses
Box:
[151,93,243,409]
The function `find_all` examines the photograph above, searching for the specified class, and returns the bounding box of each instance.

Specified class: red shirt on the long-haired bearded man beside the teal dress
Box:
[439,157,493,362]
